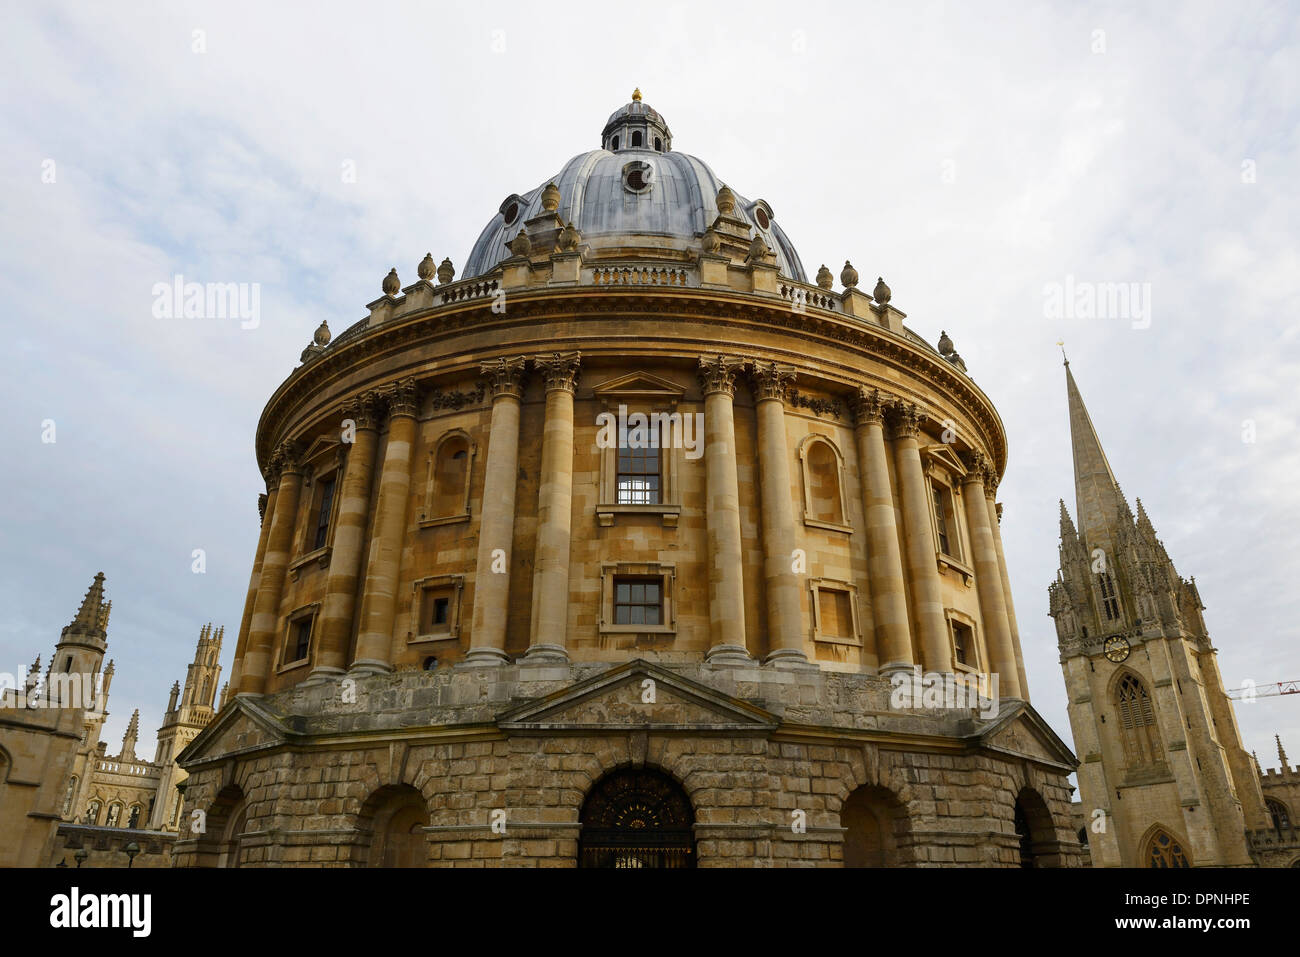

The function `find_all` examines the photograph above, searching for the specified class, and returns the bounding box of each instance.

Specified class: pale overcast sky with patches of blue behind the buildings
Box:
[0,0,1300,767]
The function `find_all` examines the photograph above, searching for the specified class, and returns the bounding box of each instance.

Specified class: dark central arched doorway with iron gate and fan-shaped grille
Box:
[577,768,696,867]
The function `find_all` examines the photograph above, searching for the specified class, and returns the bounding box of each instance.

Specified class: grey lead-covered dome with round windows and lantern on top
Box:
[464,91,807,282]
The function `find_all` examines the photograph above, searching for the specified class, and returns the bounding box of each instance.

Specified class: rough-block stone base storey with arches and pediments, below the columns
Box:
[173,661,1079,867]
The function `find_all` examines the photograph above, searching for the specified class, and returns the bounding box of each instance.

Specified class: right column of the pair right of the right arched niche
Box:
[893,403,953,672]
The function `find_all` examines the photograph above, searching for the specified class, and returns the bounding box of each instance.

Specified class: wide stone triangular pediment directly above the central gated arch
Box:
[497,659,779,733]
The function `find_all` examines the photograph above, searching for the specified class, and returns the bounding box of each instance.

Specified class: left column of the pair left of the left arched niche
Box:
[307,393,381,681]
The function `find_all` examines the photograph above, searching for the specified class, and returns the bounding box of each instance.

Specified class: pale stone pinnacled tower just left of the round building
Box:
[150,623,225,831]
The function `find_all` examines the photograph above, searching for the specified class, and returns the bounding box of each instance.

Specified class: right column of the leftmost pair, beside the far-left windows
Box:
[239,442,303,694]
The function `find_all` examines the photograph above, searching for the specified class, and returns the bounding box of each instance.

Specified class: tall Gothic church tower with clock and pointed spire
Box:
[1048,361,1265,867]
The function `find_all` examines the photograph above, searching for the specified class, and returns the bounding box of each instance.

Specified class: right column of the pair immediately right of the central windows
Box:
[753,363,807,666]
